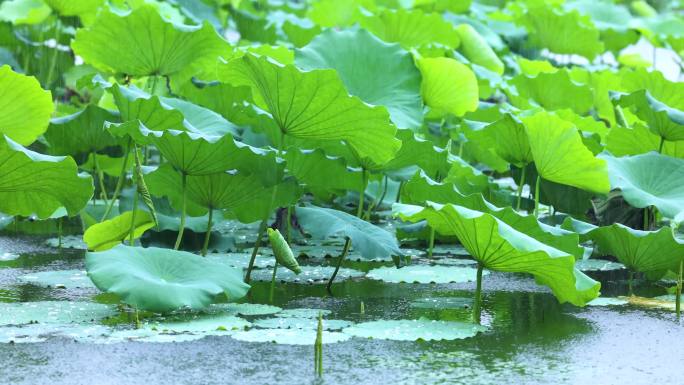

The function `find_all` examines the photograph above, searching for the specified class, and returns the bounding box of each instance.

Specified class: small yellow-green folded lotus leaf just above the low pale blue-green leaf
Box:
[83,210,154,251]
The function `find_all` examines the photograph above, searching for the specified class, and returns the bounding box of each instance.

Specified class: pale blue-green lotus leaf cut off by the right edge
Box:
[600,152,684,222]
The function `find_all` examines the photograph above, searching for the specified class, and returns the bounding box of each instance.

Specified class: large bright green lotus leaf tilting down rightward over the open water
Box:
[400,204,601,306]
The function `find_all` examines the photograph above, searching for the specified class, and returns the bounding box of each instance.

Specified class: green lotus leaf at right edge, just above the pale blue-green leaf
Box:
[611,90,684,141]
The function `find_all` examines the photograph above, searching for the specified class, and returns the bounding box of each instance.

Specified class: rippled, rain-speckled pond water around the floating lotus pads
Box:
[0,232,684,385]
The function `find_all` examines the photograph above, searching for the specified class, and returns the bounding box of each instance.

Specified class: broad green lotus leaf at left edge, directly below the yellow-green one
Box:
[0,136,93,219]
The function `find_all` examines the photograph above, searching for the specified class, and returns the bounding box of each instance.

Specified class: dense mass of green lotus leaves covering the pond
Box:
[0,0,684,364]
